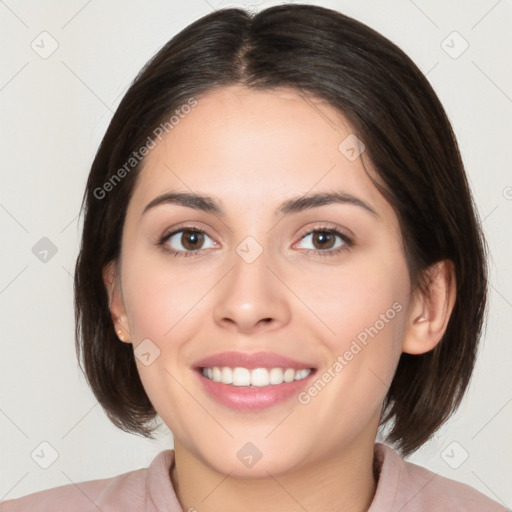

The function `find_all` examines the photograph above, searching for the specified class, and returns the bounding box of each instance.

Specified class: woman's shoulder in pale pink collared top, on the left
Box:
[0,450,173,512]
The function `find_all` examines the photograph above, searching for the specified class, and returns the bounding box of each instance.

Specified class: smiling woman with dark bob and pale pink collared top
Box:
[0,5,505,512]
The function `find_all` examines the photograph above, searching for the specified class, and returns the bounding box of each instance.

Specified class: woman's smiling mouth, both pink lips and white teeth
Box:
[194,352,316,411]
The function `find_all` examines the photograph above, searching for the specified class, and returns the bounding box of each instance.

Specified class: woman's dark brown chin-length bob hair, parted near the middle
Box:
[74,4,487,455]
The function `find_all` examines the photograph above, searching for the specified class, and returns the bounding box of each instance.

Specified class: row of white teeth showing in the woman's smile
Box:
[202,366,312,387]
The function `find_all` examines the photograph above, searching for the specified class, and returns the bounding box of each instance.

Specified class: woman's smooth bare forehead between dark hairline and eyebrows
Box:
[130,86,383,220]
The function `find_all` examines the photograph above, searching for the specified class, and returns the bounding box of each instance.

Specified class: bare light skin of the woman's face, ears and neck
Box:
[104,86,455,512]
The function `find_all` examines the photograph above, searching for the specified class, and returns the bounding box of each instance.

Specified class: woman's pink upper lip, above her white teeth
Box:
[194,352,314,370]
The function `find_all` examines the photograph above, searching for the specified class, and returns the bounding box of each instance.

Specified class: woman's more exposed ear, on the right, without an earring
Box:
[402,260,456,354]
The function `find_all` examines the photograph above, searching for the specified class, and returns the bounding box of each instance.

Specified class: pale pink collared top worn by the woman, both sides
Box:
[0,443,507,512]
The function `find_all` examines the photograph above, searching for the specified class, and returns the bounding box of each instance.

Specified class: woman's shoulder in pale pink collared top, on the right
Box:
[369,443,507,512]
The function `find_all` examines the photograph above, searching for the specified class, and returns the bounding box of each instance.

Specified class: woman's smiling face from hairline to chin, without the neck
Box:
[106,86,411,477]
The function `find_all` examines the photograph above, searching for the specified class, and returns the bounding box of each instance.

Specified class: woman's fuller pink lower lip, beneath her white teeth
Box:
[197,370,315,411]
